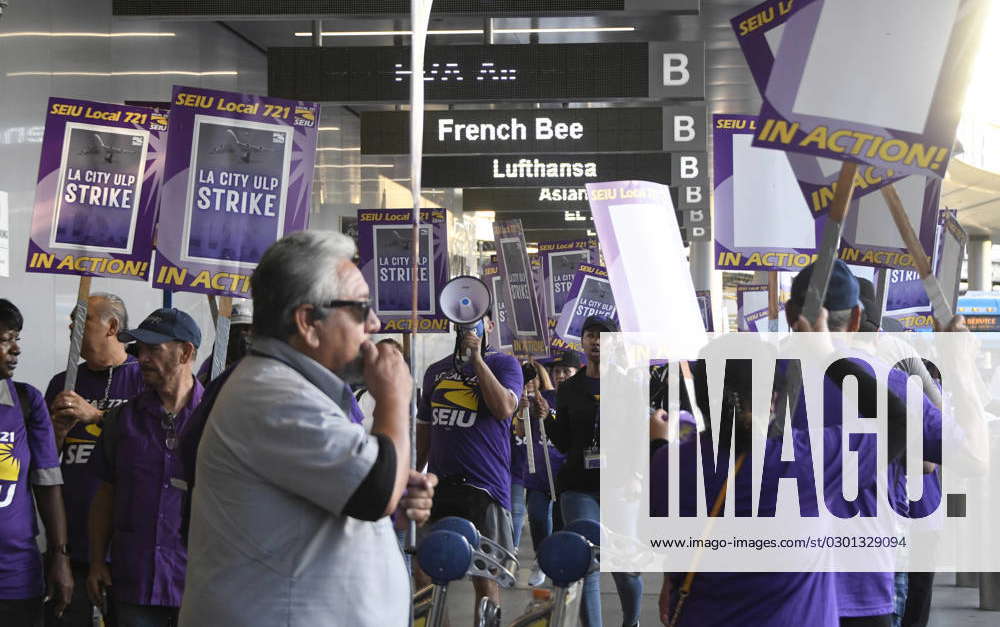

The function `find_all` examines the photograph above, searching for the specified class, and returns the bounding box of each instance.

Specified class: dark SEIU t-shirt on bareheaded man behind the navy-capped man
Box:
[45,355,146,562]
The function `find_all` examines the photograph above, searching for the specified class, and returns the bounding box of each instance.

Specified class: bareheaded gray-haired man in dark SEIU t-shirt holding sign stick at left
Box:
[45,292,145,627]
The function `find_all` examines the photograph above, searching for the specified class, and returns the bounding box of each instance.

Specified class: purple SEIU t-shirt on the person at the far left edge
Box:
[0,379,59,600]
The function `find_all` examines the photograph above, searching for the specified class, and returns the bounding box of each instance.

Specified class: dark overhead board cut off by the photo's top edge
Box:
[112,0,701,17]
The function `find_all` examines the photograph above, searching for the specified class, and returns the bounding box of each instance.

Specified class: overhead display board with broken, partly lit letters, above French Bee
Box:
[267,42,705,103]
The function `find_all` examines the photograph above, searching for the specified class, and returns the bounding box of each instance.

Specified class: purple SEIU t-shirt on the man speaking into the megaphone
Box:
[417,352,524,510]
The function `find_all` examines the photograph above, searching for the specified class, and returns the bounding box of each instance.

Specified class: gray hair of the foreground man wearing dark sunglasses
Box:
[250,231,356,340]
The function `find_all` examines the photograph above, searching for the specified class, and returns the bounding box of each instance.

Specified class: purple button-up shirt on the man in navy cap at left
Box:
[90,379,204,607]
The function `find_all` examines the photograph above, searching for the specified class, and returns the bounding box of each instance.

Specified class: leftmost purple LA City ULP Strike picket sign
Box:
[25,98,167,281]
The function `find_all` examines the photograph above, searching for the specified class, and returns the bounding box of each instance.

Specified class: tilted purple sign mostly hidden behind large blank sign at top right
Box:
[731,0,900,215]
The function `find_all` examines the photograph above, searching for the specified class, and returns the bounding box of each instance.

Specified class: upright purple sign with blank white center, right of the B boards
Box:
[712,115,826,270]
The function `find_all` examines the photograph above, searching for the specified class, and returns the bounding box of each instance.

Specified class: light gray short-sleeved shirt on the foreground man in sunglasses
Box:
[180,338,410,627]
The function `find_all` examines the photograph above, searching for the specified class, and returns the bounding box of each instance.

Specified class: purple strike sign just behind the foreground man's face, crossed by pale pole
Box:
[358,209,448,333]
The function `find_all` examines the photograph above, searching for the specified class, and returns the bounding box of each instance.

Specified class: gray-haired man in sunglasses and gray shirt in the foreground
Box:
[180,231,436,627]
